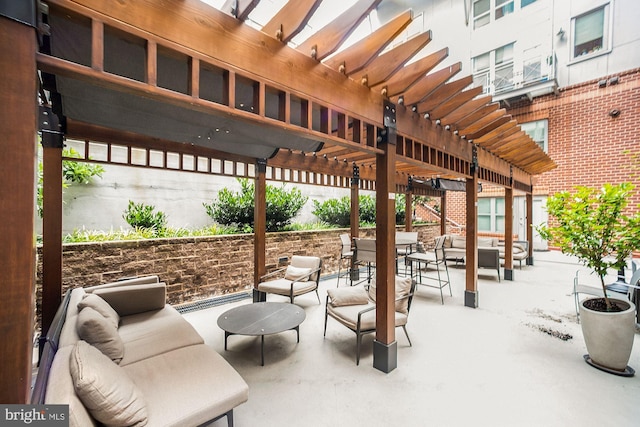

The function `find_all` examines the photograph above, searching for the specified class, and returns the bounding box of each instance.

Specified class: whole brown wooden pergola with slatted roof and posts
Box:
[0,0,555,403]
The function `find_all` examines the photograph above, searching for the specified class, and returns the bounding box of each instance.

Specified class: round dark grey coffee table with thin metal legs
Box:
[218,302,306,366]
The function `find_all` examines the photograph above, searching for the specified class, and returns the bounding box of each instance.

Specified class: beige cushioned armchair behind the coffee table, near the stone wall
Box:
[258,255,322,304]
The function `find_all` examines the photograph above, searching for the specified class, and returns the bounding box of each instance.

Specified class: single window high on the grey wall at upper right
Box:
[572,4,609,58]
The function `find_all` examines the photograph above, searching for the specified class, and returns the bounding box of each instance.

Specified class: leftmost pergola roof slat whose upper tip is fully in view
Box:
[324,11,412,75]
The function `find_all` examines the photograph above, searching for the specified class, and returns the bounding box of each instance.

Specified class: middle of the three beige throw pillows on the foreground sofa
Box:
[76,307,124,363]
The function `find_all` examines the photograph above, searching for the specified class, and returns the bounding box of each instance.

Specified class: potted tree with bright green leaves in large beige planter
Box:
[537,183,640,376]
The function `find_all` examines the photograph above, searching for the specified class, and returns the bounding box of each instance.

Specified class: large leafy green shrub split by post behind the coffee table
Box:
[202,179,308,233]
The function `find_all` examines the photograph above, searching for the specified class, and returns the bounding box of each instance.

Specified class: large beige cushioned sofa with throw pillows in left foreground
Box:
[32,276,248,427]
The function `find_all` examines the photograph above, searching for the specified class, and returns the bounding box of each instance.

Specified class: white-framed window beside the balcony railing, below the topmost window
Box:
[472,43,513,93]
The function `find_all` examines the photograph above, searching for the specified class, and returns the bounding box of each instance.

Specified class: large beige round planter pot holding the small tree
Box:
[580,298,636,376]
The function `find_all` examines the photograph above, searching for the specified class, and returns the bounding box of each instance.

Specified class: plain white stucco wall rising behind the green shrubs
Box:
[36,165,350,234]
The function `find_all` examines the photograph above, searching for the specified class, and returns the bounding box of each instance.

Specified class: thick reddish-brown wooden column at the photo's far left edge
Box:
[0,12,38,404]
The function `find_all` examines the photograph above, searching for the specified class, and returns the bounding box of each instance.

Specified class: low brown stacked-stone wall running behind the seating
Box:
[36,224,440,318]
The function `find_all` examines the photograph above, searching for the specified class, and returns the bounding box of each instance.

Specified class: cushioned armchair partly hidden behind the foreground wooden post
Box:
[324,276,415,365]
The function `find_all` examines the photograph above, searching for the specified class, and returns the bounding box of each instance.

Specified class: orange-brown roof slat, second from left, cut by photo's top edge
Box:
[262,0,322,43]
